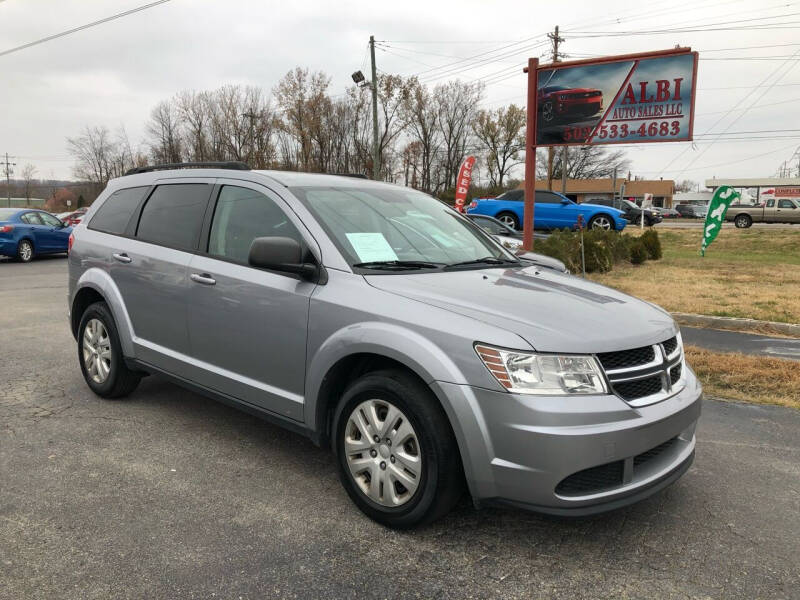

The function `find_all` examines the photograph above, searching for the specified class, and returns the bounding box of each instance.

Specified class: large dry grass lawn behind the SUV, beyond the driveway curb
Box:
[590,228,800,323]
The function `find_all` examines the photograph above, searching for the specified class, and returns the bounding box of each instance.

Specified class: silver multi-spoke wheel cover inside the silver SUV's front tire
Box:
[344,399,422,507]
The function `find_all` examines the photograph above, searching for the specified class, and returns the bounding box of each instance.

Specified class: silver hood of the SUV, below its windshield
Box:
[364,267,678,353]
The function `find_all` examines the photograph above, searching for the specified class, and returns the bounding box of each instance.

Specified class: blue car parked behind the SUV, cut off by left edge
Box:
[0,208,72,262]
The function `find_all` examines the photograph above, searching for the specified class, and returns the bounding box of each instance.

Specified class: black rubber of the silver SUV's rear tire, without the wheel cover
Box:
[78,302,141,400]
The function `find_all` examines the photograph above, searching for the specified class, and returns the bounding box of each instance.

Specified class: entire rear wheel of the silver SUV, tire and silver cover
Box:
[78,302,141,398]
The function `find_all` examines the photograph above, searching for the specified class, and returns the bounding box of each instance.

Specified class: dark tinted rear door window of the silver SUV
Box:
[136,183,212,251]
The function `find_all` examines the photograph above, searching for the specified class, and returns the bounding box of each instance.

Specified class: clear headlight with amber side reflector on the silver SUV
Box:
[475,344,608,396]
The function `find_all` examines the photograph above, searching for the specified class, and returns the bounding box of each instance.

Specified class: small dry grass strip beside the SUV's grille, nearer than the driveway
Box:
[685,346,800,408]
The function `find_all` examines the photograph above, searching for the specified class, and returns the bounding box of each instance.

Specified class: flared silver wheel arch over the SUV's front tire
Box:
[304,321,467,431]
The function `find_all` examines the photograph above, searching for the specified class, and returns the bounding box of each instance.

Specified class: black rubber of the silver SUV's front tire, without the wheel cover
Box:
[332,370,464,529]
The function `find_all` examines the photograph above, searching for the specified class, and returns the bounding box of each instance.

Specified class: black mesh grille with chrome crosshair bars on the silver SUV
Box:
[597,336,683,406]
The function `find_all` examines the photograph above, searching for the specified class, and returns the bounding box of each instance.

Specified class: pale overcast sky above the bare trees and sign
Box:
[0,0,800,182]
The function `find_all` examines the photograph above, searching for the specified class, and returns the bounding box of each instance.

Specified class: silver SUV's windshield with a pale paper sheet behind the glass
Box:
[291,187,519,270]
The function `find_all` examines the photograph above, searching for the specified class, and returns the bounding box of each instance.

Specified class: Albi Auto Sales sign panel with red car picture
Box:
[536,48,697,146]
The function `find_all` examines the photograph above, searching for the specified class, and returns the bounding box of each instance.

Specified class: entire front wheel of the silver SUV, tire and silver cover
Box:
[334,370,463,529]
